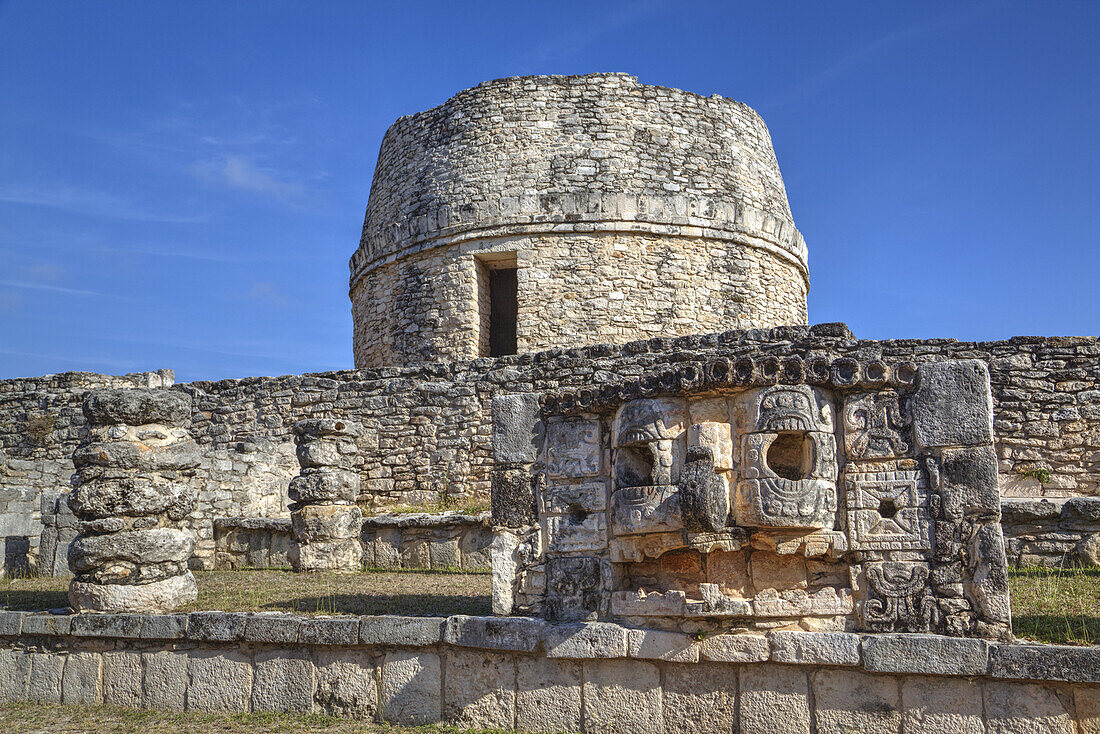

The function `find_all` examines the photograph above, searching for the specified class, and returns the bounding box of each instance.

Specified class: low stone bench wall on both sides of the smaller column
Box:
[213,513,493,571]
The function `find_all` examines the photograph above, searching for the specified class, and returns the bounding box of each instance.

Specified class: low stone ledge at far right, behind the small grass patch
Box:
[1001,497,1100,568]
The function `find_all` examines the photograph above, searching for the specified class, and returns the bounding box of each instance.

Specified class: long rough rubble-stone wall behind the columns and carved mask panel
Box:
[0,325,1100,567]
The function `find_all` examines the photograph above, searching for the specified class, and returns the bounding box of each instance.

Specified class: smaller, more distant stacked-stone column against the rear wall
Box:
[289,418,363,571]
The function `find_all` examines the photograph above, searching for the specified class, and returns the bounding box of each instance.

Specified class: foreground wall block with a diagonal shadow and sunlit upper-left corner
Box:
[382,651,442,725]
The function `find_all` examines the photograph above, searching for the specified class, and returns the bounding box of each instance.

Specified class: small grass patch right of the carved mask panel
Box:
[1009,568,1100,645]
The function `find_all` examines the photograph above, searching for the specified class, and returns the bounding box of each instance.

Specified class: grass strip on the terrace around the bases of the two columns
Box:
[0,569,493,616]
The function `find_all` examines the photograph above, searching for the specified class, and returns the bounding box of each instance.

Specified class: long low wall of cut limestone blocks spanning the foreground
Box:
[0,612,1100,734]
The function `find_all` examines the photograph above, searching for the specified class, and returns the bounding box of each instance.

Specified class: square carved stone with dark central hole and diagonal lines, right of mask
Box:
[845,470,932,550]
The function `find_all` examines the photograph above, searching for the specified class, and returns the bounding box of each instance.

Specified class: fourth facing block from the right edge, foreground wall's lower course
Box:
[813,670,901,734]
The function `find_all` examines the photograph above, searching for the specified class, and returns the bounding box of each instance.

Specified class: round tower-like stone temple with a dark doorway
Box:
[351,74,809,368]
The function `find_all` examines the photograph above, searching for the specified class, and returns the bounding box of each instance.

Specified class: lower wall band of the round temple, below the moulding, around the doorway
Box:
[351,232,806,365]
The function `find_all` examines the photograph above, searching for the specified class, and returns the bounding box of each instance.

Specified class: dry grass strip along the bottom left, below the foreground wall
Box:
[0,703,510,734]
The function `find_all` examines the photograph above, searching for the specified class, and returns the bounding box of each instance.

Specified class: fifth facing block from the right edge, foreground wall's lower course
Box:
[739,664,810,734]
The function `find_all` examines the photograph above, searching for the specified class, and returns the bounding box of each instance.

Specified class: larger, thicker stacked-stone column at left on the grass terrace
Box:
[68,388,200,612]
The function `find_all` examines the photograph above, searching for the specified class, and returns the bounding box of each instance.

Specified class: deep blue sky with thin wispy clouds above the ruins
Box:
[0,0,1100,381]
